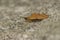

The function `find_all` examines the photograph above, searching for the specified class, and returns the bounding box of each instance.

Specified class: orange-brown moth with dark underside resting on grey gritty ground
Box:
[25,13,48,22]
